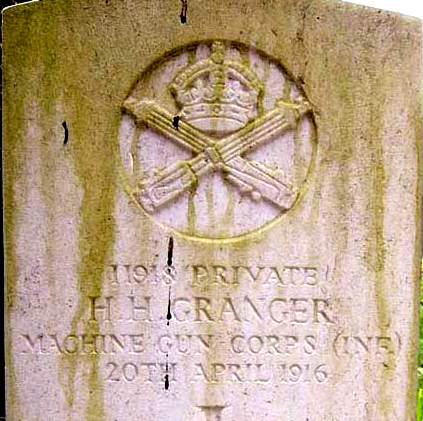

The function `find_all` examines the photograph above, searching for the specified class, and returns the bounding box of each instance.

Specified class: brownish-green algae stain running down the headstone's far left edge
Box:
[2,5,48,421]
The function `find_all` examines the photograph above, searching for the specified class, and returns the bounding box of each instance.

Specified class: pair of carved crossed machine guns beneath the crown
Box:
[124,98,310,212]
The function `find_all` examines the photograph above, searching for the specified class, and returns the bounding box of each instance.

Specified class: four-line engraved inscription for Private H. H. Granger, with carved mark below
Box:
[19,256,401,406]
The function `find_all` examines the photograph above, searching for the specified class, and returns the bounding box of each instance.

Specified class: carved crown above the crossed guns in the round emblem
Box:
[169,42,263,136]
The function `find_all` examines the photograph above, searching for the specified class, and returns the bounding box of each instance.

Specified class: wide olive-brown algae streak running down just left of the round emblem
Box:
[52,9,121,421]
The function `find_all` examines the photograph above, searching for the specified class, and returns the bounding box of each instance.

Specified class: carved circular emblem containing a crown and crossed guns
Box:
[119,41,316,240]
